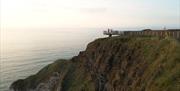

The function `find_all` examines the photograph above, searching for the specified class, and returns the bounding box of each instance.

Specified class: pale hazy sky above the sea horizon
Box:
[0,0,180,28]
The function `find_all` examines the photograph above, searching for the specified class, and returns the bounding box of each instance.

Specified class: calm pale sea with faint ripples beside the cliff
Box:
[0,28,104,91]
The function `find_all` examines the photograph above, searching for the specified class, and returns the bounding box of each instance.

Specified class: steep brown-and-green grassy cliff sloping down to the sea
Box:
[10,37,180,91]
